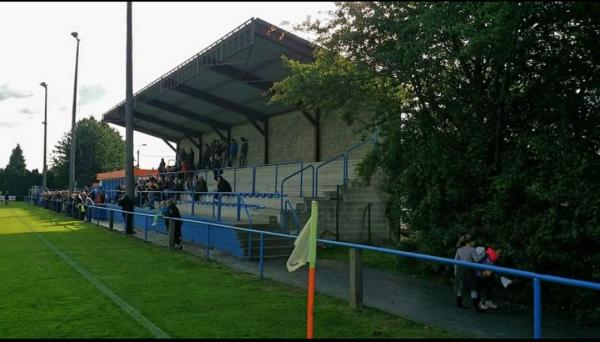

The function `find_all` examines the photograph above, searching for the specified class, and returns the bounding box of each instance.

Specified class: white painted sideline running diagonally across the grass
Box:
[19,215,171,338]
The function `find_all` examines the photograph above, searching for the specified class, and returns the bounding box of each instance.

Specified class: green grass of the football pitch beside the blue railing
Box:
[0,203,460,338]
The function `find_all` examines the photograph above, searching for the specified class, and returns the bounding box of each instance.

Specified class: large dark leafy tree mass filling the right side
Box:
[273,2,600,318]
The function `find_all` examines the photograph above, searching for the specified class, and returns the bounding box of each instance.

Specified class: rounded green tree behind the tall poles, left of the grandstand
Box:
[50,117,125,188]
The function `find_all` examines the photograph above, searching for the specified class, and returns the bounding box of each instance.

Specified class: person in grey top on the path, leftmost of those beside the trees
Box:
[454,234,485,312]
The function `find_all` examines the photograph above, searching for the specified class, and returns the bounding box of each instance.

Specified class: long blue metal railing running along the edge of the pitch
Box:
[74,206,600,339]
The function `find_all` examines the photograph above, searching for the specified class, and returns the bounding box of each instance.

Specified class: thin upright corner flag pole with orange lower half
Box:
[306,201,319,339]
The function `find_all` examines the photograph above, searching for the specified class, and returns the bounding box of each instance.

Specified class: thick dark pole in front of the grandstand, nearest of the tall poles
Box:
[125,1,133,200]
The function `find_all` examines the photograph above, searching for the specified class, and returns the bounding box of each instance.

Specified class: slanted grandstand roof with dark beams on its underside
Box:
[103,18,314,143]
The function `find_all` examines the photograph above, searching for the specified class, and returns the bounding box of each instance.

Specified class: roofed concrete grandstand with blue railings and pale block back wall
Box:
[99,18,388,256]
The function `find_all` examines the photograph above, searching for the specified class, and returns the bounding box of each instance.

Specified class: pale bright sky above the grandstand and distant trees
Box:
[0,2,335,172]
